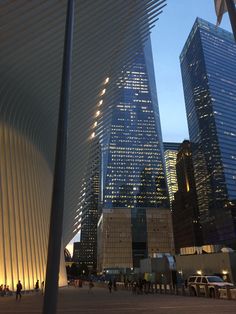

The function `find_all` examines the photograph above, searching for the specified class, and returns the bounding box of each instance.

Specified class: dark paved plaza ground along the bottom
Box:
[0,287,236,314]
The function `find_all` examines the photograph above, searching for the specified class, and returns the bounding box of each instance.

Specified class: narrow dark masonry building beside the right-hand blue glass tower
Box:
[172,140,202,253]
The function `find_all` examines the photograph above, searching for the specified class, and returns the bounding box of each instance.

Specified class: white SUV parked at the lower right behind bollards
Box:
[187,276,234,298]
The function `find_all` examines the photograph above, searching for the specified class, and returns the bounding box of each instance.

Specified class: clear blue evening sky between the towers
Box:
[151,0,231,142]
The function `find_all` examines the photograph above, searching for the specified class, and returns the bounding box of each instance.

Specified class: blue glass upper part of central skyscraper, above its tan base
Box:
[102,38,167,208]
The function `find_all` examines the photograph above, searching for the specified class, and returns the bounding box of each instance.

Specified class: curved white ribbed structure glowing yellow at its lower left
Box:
[0,0,165,289]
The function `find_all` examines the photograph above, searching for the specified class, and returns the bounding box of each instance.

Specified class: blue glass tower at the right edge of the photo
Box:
[180,18,236,248]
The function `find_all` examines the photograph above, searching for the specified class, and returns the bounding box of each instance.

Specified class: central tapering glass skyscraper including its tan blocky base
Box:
[98,40,173,270]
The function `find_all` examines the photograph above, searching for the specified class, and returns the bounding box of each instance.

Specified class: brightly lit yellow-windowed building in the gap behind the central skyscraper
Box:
[163,142,180,208]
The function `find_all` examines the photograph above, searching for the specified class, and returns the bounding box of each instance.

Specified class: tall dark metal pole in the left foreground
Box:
[43,0,74,314]
